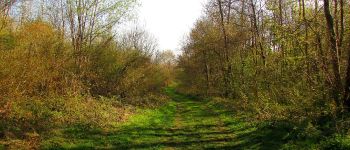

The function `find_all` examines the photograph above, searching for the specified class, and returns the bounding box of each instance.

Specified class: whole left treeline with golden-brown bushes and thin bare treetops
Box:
[0,0,173,145]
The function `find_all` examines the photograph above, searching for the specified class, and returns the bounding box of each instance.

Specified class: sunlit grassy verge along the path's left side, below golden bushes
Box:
[41,102,175,149]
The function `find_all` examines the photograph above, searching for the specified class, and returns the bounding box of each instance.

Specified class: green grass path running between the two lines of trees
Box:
[43,90,292,149]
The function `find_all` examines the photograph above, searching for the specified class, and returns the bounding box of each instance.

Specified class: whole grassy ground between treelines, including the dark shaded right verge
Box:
[4,88,350,149]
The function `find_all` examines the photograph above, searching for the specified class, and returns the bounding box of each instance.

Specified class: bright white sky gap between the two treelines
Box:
[138,0,207,54]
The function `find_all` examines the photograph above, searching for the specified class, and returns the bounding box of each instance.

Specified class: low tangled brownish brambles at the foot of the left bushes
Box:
[0,97,127,137]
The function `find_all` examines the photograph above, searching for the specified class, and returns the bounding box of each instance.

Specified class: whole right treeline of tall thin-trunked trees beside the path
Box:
[178,0,350,132]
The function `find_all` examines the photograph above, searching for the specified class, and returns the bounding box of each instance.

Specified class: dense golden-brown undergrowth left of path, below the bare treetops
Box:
[0,14,170,149]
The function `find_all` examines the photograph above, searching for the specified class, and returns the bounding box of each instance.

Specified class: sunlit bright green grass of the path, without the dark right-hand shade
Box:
[42,88,253,149]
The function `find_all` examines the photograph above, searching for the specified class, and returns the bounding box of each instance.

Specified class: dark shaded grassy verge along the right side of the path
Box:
[207,96,350,150]
